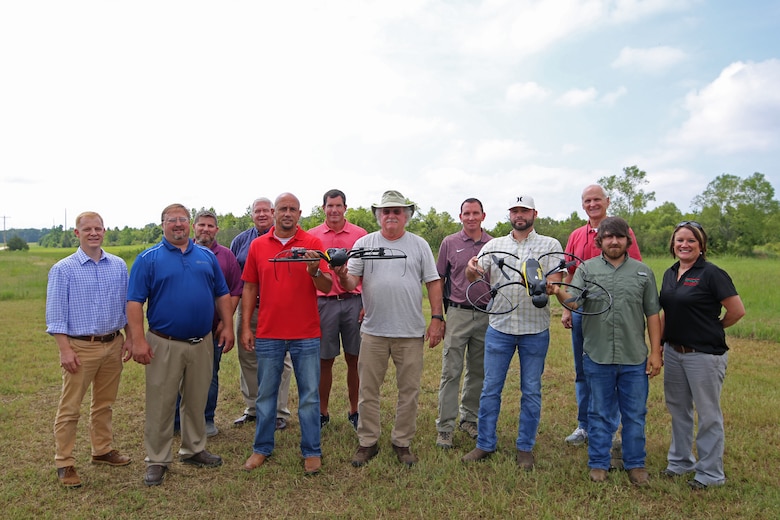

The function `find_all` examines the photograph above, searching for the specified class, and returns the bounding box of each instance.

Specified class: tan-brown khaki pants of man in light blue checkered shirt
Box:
[54,334,124,468]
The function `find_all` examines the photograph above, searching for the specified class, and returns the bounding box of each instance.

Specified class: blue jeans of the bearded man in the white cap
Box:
[477,327,550,451]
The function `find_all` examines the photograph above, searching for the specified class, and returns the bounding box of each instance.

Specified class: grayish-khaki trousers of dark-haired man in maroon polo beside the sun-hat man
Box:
[436,307,488,432]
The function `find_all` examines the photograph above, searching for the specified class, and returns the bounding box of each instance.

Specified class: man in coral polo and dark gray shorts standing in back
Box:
[309,190,366,430]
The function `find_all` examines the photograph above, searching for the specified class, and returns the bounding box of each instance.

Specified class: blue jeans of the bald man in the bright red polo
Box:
[252,338,322,457]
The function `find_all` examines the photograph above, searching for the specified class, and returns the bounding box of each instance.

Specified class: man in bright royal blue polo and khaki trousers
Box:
[127,204,234,486]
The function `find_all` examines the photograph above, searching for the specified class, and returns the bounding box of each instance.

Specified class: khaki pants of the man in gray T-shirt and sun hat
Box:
[358,333,423,447]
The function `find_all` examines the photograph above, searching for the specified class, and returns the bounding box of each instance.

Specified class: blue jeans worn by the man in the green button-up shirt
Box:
[583,355,650,470]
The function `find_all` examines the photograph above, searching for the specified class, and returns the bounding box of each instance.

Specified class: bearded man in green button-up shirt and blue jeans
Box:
[552,217,662,486]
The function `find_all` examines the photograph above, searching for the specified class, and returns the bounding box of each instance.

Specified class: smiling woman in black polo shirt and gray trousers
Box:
[661,221,745,489]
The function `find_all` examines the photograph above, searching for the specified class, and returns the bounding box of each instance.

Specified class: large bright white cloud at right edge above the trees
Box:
[669,59,780,153]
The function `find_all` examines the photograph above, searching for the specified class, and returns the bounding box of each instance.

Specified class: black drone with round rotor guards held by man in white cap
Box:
[466,251,612,316]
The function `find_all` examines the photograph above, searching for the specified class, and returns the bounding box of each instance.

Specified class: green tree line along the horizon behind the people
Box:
[8,166,780,256]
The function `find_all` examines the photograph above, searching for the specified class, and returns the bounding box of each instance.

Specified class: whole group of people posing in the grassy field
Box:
[46,185,745,489]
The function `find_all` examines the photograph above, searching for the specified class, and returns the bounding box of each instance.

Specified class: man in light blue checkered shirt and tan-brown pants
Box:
[46,212,132,487]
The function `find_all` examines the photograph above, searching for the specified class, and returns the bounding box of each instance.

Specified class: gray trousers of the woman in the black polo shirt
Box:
[664,345,728,486]
